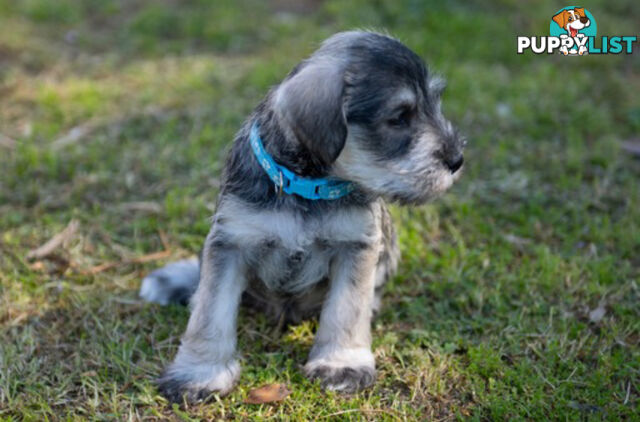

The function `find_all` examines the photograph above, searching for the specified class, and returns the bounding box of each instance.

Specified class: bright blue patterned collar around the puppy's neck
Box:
[249,123,355,200]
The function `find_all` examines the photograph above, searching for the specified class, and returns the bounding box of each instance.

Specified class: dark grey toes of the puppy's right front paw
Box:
[307,366,376,393]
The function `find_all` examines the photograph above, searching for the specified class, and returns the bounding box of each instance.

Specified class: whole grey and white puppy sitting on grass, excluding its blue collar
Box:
[140,31,463,401]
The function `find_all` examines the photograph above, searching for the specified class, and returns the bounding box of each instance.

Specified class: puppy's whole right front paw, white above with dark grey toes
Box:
[304,349,376,393]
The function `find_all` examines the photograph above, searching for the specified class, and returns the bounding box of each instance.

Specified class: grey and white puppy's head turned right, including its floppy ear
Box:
[275,32,463,203]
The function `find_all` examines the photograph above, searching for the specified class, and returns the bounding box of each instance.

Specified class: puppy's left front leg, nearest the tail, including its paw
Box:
[158,229,246,402]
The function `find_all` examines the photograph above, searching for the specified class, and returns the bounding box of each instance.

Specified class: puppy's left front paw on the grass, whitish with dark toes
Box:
[157,360,240,403]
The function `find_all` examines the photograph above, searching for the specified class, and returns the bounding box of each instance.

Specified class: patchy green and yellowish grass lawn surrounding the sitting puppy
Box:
[0,0,640,421]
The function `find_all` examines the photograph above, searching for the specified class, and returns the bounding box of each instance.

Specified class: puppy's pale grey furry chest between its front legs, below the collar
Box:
[221,198,379,294]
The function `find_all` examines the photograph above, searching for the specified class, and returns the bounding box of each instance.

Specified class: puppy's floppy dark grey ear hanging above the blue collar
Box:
[275,59,347,165]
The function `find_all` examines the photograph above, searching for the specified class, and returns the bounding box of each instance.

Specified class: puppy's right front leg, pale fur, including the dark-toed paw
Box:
[305,247,378,393]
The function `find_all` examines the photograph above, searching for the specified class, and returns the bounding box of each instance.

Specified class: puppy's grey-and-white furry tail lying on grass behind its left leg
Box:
[140,258,200,305]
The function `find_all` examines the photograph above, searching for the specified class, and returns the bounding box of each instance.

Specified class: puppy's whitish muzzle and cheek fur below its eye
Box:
[333,128,459,204]
